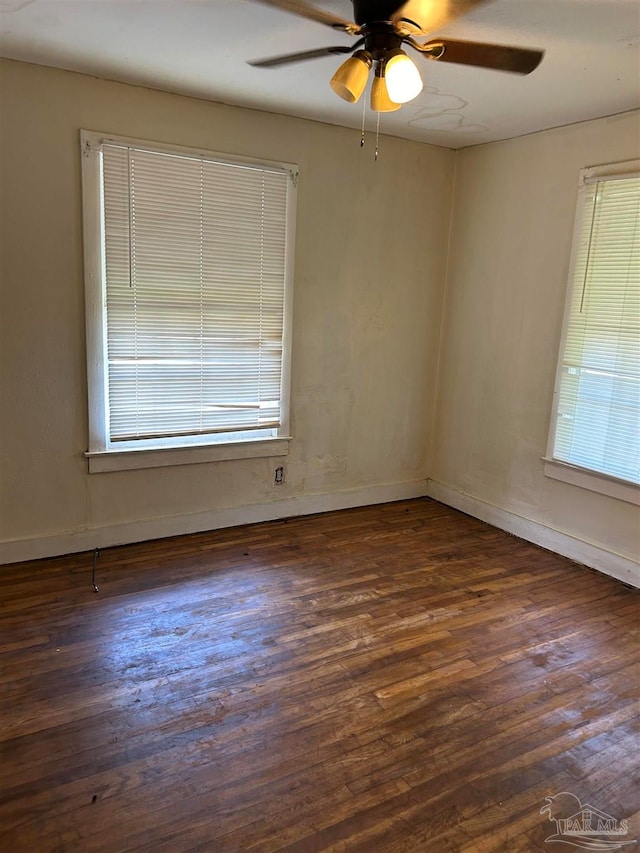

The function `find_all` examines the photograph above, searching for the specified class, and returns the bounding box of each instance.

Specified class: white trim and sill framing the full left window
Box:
[80,130,298,473]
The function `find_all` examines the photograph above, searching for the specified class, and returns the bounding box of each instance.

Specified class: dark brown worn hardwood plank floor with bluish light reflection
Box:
[0,499,640,853]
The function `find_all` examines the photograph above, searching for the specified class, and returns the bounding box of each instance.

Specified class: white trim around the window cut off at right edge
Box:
[542,160,640,505]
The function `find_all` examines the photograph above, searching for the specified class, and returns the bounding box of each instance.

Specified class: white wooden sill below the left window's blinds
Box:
[85,438,290,474]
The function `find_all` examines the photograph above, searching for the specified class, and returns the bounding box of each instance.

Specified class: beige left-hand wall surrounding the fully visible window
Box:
[0,62,454,557]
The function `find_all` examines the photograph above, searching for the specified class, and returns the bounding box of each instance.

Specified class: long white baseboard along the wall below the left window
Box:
[0,480,427,565]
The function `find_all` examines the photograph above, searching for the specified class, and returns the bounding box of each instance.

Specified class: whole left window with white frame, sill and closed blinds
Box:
[81,131,297,470]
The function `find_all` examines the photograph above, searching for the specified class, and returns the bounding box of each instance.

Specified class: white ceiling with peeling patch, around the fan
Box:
[0,0,640,148]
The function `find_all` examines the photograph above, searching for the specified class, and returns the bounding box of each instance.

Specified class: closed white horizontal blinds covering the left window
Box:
[101,143,289,441]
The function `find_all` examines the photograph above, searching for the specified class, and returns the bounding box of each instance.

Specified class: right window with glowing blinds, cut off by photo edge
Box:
[546,163,640,501]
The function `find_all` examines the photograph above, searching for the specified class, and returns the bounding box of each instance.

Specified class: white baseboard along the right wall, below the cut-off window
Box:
[427,480,640,587]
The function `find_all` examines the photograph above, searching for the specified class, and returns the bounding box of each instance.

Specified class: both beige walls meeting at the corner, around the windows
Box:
[0,62,639,572]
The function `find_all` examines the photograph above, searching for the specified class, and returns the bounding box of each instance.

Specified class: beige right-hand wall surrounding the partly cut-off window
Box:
[430,113,640,560]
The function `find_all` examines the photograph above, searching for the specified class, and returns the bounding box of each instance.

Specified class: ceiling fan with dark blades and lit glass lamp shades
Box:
[249,0,544,112]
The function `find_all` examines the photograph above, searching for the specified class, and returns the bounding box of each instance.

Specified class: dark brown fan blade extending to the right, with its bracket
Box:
[416,39,544,74]
